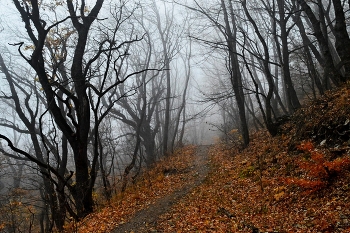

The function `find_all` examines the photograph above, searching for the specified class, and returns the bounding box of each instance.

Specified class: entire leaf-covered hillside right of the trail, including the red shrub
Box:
[158,86,350,232]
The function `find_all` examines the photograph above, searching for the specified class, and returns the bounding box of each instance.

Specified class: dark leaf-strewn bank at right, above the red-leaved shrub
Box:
[285,83,350,147]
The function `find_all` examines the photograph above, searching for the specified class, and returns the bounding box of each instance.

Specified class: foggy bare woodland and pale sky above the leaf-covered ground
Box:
[0,0,350,232]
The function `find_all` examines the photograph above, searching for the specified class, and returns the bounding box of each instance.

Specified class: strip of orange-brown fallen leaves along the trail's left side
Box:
[66,146,196,233]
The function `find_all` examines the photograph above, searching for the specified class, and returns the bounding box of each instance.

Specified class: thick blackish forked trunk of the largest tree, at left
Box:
[9,0,109,219]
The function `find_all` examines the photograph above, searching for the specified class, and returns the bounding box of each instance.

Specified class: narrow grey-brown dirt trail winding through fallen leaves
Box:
[111,146,209,233]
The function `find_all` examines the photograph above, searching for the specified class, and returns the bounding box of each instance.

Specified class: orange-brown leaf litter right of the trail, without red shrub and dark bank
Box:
[158,132,350,232]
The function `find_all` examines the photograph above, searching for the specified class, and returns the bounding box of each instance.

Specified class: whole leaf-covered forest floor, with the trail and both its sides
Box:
[69,85,350,233]
